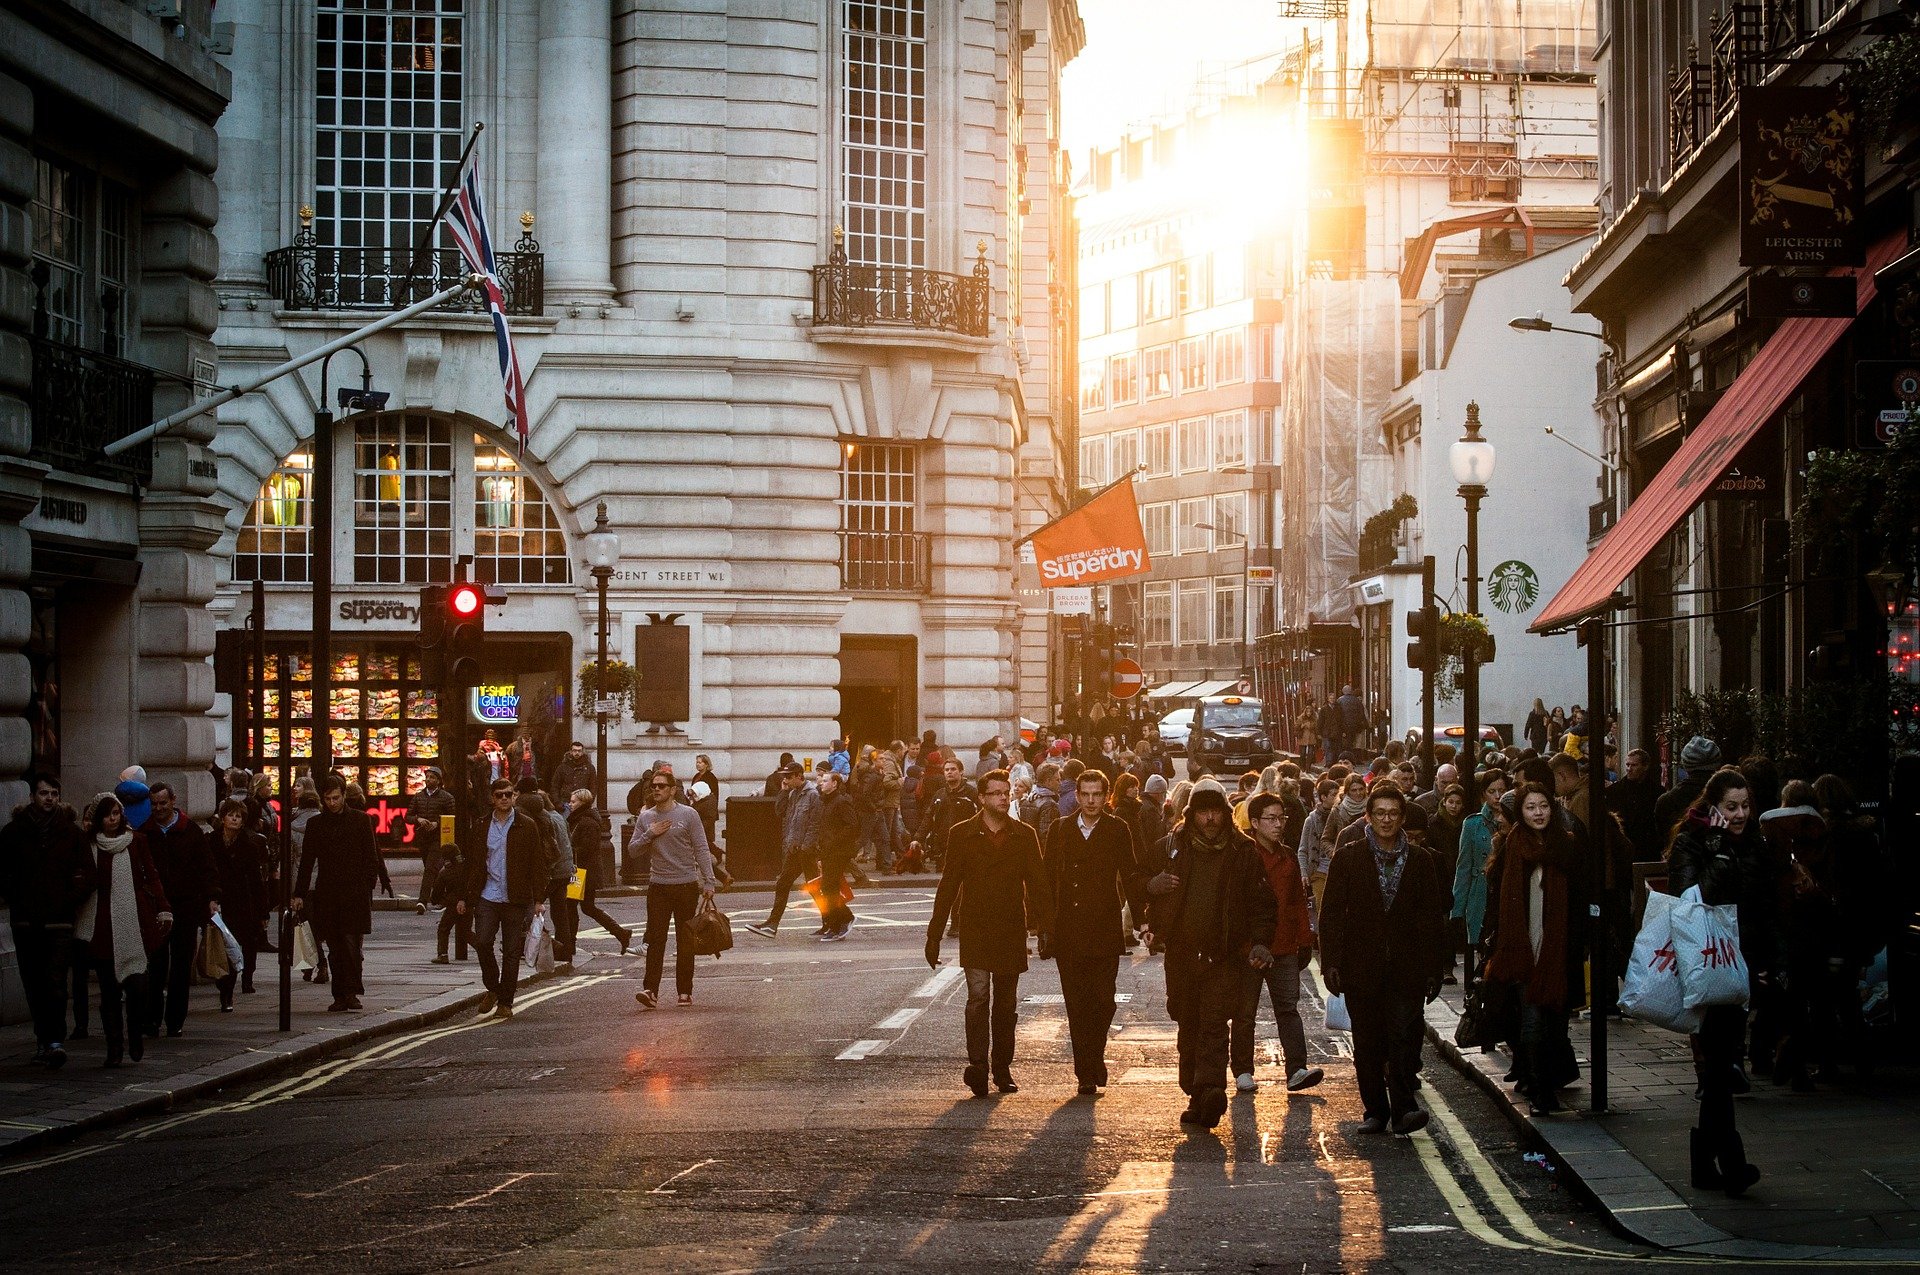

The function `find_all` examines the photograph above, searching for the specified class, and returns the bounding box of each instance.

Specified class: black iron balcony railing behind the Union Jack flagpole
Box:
[267,219,547,315]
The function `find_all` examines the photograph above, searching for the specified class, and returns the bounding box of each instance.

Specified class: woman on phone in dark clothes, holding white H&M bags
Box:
[1667,768,1780,1196]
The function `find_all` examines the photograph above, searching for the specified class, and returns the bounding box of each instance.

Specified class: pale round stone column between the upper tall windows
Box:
[534,0,612,305]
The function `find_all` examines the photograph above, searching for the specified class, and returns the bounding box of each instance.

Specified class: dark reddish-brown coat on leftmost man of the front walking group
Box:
[927,816,1052,974]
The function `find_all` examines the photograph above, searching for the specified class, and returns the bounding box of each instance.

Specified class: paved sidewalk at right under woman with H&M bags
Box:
[1427,987,1920,1262]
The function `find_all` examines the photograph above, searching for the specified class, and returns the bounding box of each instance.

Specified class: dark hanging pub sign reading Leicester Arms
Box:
[1740,81,1866,268]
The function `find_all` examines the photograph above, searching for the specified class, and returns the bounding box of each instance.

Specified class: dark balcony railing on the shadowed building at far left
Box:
[31,336,154,484]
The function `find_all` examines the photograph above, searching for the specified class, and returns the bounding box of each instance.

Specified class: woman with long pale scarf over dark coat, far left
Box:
[73,793,173,1068]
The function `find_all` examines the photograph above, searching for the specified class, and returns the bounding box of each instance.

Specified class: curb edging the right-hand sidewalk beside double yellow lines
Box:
[1425,1000,1920,1265]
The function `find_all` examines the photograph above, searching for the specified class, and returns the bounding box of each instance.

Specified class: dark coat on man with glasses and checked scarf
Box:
[1319,839,1448,997]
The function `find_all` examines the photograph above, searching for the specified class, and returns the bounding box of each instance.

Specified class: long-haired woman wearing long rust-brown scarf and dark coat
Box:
[1486,783,1584,1116]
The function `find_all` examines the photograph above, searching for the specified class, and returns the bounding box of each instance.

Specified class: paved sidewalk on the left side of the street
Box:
[0,902,643,1156]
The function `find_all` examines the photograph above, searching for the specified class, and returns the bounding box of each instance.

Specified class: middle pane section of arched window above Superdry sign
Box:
[353,413,453,584]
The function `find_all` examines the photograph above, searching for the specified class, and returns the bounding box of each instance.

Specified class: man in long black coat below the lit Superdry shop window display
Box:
[292,772,394,1014]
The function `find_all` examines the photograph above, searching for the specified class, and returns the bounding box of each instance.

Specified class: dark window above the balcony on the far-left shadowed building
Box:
[29,157,132,355]
